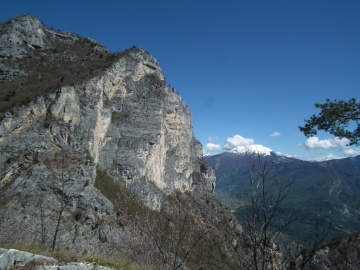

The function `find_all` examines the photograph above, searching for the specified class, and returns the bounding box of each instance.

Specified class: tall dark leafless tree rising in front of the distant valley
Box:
[236,154,296,270]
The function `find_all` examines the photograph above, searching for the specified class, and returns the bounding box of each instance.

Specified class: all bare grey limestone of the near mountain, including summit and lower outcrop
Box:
[0,16,221,262]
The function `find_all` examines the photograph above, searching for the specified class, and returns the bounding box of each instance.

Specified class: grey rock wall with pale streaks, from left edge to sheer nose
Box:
[0,49,215,208]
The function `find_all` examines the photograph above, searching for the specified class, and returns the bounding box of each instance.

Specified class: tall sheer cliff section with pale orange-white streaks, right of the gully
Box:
[77,49,214,200]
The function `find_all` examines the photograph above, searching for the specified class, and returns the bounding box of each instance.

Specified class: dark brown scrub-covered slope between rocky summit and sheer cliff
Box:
[0,28,138,118]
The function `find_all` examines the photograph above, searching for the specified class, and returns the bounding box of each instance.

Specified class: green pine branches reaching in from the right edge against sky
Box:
[299,98,360,145]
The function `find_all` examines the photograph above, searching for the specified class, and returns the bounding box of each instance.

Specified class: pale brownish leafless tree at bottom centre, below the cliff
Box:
[112,187,207,270]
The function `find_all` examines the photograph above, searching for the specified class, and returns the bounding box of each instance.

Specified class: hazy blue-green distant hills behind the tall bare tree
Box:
[204,152,360,236]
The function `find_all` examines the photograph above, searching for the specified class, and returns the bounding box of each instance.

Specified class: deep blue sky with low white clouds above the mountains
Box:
[0,0,360,160]
